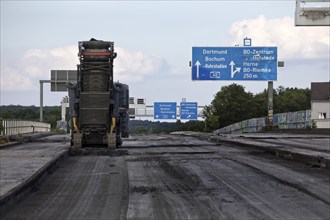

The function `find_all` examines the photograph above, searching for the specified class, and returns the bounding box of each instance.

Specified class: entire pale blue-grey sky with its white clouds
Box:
[0,0,330,106]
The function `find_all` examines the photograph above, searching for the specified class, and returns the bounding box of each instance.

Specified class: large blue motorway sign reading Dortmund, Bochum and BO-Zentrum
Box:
[191,47,277,81]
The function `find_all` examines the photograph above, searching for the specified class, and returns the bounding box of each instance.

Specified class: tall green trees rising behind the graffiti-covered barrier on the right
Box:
[203,83,311,131]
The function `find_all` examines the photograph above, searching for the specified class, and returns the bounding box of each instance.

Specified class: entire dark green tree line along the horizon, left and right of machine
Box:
[0,83,311,134]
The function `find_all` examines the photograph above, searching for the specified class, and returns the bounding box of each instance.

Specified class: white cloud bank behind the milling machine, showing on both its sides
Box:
[1,46,168,91]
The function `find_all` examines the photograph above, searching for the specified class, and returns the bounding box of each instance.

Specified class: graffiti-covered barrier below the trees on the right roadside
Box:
[214,110,312,134]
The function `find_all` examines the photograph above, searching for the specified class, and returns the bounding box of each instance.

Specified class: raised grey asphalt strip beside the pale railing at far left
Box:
[0,135,69,201]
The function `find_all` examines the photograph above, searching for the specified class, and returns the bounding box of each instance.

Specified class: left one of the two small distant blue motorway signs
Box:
[154,102,176,119]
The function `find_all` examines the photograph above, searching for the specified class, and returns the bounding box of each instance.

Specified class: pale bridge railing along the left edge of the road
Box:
[0,119,50,135]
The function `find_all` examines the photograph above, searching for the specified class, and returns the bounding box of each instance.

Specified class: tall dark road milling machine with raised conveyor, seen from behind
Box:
[68,38,129,149]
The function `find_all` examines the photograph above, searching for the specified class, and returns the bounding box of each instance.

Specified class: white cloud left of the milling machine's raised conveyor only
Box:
[1,46,78,91]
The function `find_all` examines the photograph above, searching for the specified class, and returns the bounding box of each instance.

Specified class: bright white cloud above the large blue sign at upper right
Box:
[229,15,330,60]
